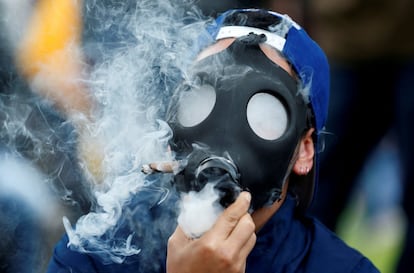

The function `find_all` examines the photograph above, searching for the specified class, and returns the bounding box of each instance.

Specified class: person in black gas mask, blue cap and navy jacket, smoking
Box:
[49,9,378,273]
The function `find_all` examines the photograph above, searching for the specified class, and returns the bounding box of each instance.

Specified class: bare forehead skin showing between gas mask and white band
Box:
[196,38,294,76]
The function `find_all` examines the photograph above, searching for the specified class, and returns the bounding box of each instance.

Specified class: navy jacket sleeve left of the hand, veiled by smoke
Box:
[48,174,178,273]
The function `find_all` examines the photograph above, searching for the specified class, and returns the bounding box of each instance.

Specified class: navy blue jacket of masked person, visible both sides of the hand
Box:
[47,193,379,273]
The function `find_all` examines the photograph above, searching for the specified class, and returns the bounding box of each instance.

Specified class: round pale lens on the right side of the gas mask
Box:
[247,93,288,140]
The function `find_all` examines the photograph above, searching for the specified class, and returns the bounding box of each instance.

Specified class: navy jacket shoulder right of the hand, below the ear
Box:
[246,194,379,273]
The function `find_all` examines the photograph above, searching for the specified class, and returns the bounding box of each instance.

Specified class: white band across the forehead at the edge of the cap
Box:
[216,26,286,52]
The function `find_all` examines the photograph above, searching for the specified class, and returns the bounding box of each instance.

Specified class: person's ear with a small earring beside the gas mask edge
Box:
[293,128,315,175]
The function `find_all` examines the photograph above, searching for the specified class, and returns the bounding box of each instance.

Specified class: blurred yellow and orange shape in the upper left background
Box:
[16,0,90,114]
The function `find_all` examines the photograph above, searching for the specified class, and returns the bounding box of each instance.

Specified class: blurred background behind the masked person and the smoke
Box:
[0,0,414,273]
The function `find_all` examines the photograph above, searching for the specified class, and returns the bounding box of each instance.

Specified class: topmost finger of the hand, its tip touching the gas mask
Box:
[213,192,251,240]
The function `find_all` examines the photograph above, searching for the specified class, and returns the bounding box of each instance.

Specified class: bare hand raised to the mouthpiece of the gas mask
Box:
[167,192,256,273]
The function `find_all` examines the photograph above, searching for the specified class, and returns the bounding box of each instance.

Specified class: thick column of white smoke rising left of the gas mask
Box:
[64,0,213,263]
